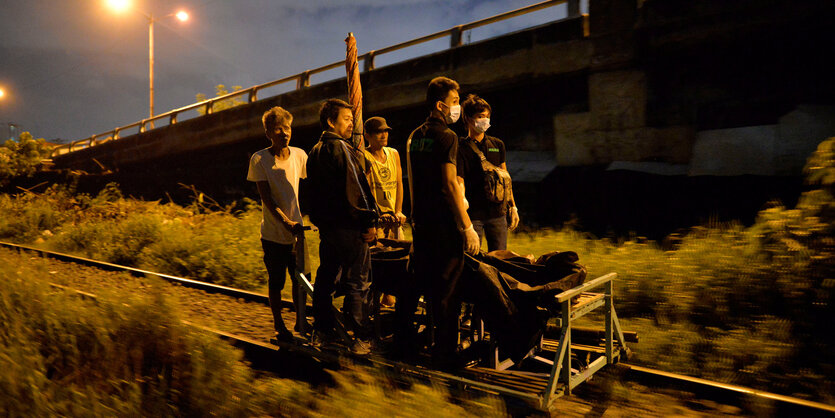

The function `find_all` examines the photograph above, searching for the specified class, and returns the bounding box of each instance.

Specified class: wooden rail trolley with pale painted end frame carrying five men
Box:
[284,240,637,410]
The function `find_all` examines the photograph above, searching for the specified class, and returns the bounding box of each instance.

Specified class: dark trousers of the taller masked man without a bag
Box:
[396,225,464,358]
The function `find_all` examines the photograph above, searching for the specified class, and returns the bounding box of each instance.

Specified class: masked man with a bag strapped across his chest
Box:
[457,94,519,251]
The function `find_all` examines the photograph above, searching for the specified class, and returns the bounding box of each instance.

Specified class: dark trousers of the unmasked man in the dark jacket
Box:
[313,228,371,338]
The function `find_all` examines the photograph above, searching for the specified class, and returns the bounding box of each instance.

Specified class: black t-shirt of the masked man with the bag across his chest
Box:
[457,135,507,221]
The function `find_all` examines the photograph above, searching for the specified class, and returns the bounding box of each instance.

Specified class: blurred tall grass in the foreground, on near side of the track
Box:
[0,254,504,417]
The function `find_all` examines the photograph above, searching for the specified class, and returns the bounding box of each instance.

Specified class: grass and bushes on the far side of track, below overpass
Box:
[0,139,835,403]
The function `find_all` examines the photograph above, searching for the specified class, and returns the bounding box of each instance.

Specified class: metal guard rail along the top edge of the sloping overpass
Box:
[50,0,580,157]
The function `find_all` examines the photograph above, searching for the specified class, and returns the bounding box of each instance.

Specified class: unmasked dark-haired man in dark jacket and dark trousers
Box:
[307,99,378,354]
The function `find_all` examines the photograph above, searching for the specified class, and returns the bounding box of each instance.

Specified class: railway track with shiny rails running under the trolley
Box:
[0,241,835,416]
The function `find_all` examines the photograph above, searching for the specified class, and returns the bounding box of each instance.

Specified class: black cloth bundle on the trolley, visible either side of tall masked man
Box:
[371,240,586,361]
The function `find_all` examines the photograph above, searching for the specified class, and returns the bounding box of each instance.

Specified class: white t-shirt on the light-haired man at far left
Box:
[246,147,307,244]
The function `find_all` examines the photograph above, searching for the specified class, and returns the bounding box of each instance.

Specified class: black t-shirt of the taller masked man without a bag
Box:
[408,111,458,226]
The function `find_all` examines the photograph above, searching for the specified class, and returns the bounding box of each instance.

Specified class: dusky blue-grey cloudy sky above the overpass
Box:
[0,0,585,140]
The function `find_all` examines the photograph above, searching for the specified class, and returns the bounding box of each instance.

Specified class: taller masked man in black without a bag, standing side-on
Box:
[396,77,478,367]
